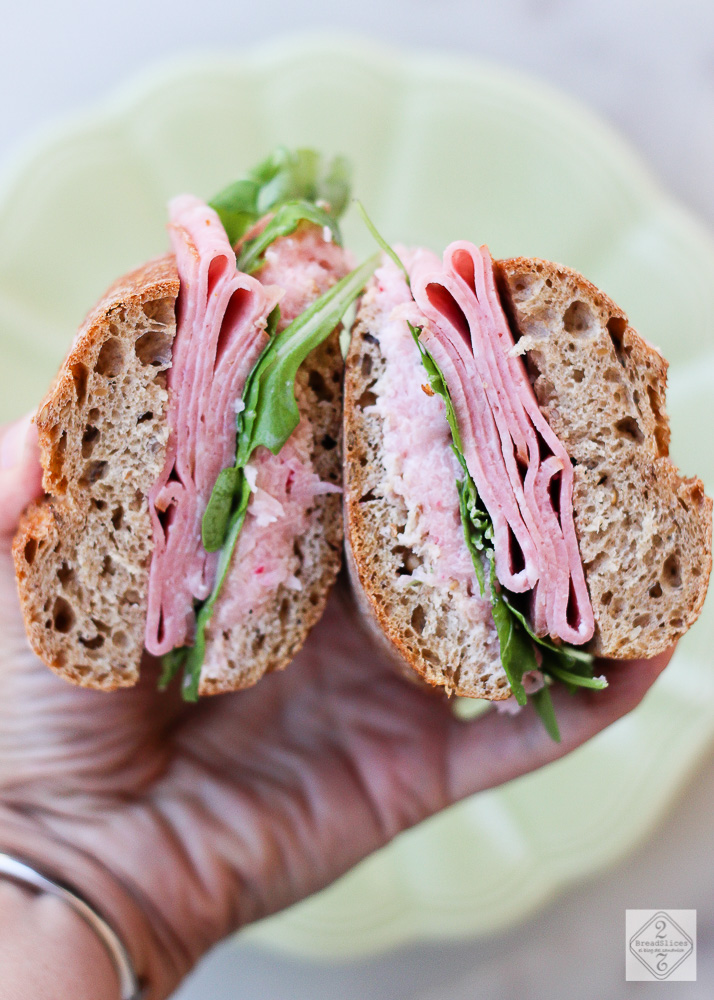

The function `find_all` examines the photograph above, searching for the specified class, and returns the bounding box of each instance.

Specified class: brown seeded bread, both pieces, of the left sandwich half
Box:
[13,256,342,694]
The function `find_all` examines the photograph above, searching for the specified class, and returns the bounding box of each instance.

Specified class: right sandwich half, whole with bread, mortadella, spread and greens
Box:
[344,230,712,739]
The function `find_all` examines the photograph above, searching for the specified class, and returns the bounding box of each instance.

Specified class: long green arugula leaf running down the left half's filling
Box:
[167,254,379,701]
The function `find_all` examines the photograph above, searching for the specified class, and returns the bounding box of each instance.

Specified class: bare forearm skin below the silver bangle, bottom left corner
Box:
[0,878,118,1000]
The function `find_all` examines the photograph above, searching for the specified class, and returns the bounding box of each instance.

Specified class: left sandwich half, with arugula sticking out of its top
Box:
[14,149,376,700]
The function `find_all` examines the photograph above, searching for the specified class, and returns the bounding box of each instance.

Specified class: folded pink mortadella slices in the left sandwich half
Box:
[145,195,281,656]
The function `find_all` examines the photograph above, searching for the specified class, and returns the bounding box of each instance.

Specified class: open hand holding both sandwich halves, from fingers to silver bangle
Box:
[0,414,671,1000]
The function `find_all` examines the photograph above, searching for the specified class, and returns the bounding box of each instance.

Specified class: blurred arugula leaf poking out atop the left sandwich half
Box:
[209,146,350,244]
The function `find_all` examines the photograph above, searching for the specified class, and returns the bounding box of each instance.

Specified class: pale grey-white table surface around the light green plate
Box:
[0,0,714,1000]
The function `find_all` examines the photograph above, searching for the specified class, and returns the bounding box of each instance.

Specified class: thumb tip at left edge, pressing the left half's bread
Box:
[0,410,42,540]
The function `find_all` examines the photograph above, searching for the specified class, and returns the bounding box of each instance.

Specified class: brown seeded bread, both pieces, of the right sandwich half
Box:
[344,258,712,700]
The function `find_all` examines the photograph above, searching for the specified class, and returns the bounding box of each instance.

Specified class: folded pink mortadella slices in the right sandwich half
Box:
[410,242,594,644]
